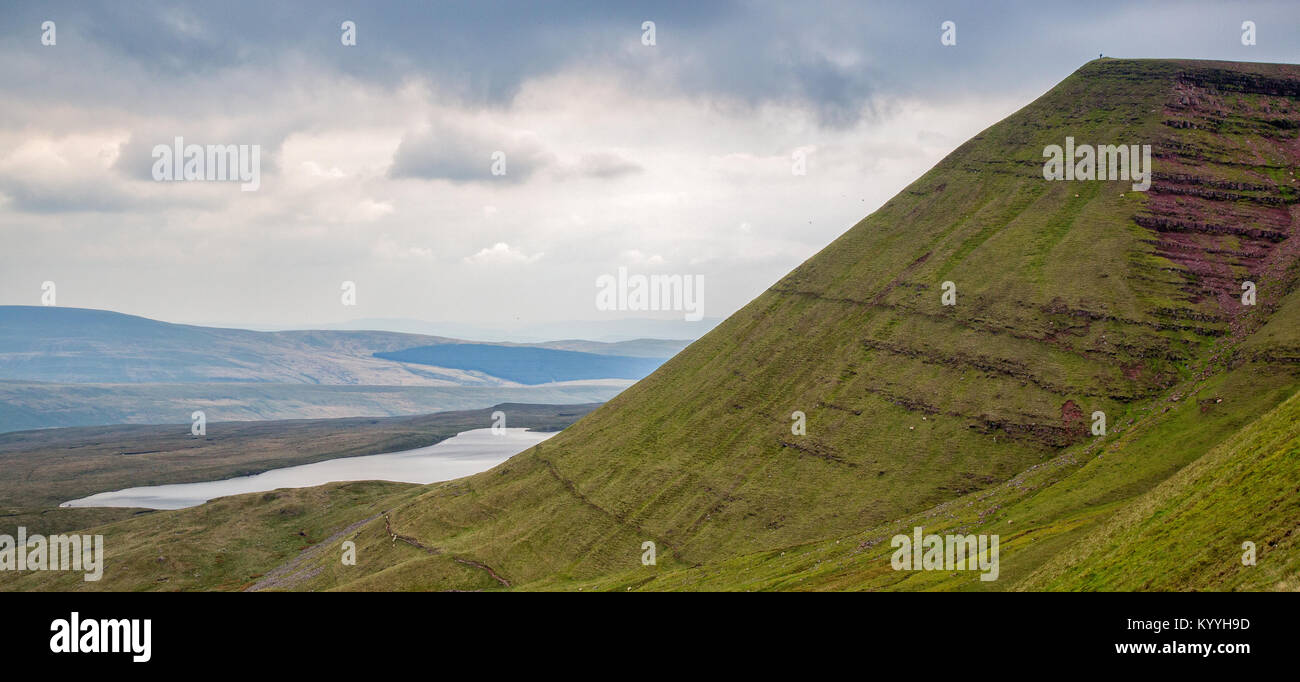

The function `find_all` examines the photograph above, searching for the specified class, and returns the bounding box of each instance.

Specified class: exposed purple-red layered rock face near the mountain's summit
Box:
[1149,68,1300,317]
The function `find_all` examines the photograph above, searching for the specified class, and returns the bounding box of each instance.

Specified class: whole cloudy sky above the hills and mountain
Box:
[0,0,1300,327]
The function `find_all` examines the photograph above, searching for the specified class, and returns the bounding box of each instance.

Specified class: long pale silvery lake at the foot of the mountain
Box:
[60,429,555,509]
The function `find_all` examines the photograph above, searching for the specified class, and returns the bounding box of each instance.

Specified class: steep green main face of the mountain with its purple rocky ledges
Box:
[289,60,1300,588]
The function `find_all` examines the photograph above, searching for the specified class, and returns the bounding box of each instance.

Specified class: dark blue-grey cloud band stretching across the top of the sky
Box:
[10,0,1300,127]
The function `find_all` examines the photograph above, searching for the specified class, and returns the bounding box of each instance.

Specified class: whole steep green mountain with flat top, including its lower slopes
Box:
[12,58,1300,591]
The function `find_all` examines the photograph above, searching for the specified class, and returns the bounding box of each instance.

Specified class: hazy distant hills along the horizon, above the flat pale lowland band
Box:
[0,305,688,386]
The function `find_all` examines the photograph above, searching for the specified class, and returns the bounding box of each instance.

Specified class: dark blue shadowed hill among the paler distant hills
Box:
[374,343,663,385]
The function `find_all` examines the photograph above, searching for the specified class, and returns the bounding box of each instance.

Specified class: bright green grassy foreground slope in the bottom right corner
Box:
[1022,384,1300,590]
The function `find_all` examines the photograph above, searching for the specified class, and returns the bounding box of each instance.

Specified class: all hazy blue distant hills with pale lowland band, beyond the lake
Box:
[0,305,688,433]
